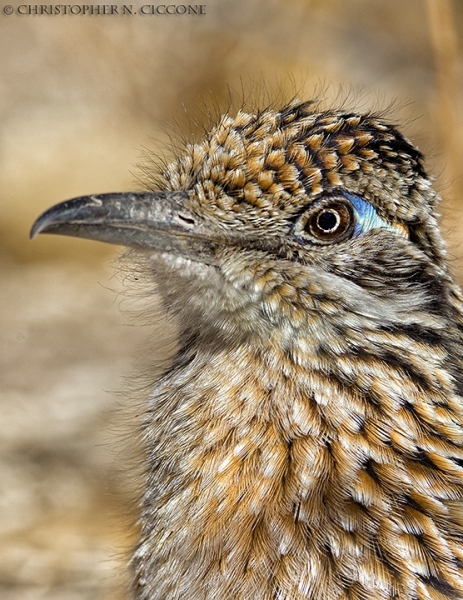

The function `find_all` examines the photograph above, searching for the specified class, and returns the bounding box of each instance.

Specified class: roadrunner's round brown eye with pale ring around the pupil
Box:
[294,198,355,244]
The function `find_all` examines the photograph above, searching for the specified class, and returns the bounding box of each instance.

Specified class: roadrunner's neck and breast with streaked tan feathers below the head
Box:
[135,322,463,600]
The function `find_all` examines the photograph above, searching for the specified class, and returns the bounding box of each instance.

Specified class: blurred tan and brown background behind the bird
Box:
[0,0,463,600]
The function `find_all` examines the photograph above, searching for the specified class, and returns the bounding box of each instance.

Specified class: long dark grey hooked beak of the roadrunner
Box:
[30,192,219,262]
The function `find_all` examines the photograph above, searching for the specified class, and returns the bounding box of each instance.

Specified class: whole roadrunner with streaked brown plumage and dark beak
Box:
[32,101,463,600]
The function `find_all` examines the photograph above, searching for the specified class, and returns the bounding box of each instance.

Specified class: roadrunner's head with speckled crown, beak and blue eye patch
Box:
[32,101,454,346]
